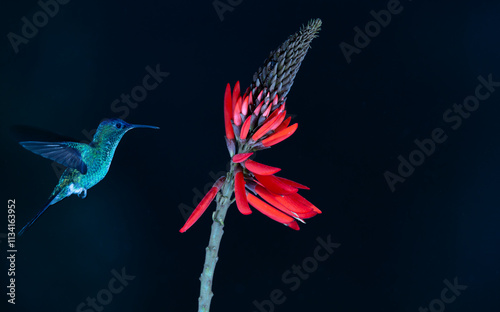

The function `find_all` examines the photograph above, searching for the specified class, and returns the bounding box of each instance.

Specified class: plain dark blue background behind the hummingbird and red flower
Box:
[0,0,500,312]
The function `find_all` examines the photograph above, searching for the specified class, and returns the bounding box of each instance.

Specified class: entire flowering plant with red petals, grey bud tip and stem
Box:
[180,19,321,312]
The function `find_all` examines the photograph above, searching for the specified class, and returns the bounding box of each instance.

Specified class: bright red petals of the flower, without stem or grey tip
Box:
[180,82,321,232]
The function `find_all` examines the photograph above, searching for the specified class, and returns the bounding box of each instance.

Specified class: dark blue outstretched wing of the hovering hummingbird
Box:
[19,141,88,174]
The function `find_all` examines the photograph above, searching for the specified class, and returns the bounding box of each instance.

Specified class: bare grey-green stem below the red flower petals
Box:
[198,164,234,312]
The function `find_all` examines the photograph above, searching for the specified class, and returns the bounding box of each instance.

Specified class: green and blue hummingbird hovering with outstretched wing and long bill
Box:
[18,118,160,236]
